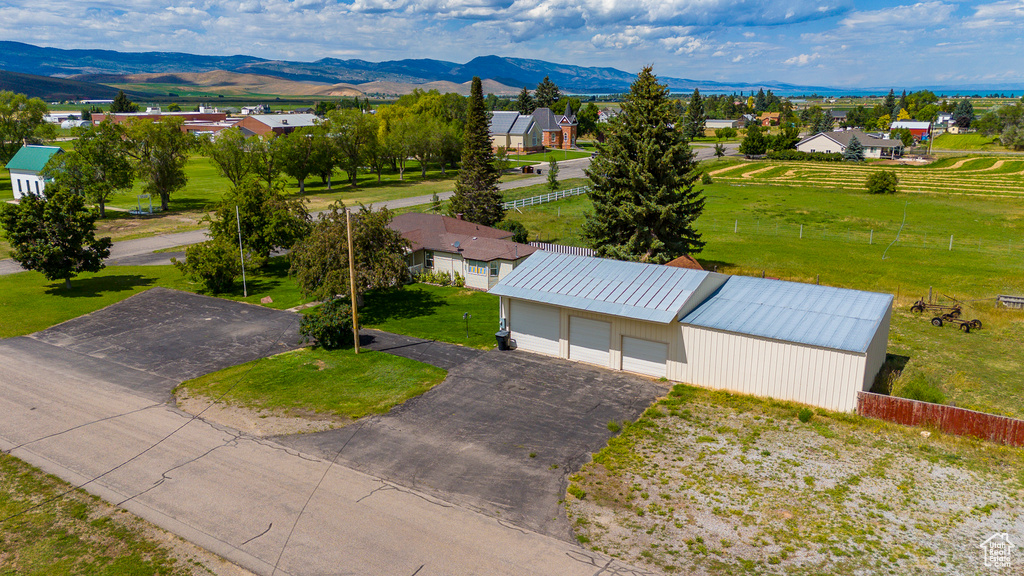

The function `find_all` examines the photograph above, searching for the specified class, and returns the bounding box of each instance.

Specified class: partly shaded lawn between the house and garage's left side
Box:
[359,284,498,349]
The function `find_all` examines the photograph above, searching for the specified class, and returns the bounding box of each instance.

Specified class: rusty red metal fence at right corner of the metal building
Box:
[857,392,1024,447]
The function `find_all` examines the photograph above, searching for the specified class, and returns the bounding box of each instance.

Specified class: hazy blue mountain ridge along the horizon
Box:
[0,41,828,93]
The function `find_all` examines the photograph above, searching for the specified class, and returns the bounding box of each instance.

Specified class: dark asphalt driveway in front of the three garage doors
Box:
[274,342,668,539]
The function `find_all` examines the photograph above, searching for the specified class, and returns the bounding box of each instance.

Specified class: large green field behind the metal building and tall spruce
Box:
[511,159,1024,418]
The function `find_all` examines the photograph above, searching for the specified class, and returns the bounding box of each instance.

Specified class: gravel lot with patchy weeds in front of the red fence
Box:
[566,386,1024,575]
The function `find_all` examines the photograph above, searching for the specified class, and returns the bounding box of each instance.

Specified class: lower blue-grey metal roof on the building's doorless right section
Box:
[680,276,893,354]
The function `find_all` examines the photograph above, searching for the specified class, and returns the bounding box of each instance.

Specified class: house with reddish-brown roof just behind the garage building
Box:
[390,212,538,290]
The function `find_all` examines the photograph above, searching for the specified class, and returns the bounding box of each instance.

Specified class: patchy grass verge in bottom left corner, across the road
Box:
[0,453,209,576]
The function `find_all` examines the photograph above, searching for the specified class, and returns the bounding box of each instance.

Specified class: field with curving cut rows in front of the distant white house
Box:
[710,157,1024,197]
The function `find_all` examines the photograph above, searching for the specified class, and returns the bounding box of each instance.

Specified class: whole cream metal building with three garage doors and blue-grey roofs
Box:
[490,252,893,411]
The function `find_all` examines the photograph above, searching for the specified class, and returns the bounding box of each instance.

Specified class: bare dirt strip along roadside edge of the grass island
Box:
[176,388,351,438]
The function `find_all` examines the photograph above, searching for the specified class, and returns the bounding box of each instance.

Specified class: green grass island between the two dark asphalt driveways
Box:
[177,348,445,419]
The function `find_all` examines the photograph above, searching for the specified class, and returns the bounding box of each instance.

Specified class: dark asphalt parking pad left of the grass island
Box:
[12,288,299,401]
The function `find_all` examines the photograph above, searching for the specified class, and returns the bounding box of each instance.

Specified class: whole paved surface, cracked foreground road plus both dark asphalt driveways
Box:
[0,288,665,576]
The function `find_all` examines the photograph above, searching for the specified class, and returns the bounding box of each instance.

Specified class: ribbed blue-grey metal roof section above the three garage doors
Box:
[490,251,710,324]
